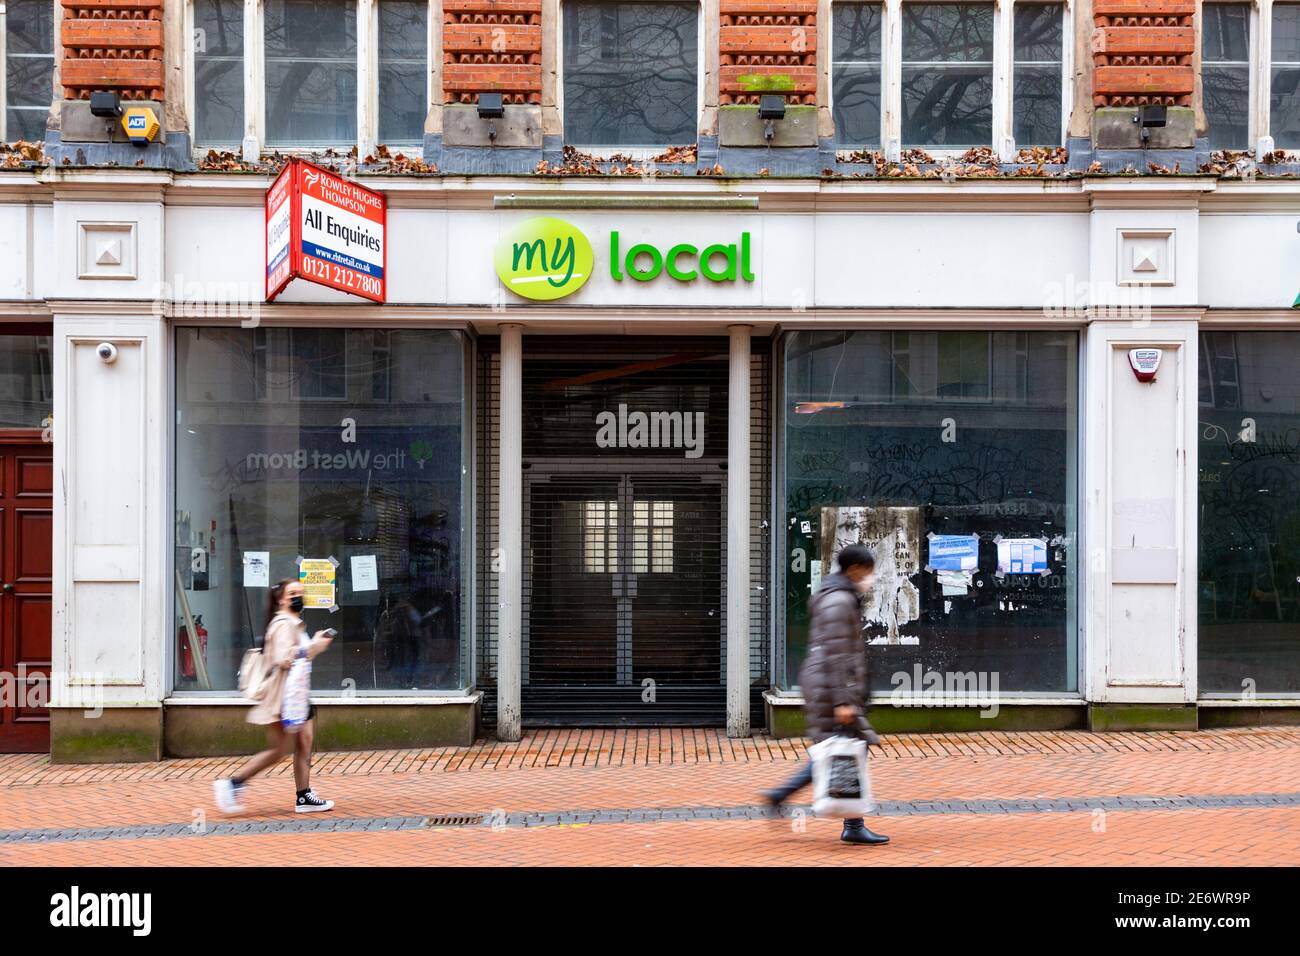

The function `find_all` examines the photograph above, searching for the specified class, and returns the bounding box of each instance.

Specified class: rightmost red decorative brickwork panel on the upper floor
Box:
[1092,0,1196,107]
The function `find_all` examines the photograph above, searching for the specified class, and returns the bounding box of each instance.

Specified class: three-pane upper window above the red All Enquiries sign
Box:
[192,0,429,150]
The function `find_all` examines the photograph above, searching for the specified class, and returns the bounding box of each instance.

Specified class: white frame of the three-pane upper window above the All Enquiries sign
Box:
[185,0,442,163]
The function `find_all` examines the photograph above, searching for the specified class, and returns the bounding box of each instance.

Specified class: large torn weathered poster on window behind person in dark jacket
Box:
[822,506,920,644]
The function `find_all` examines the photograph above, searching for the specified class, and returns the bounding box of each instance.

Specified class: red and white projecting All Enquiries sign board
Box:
[267,159,387,302]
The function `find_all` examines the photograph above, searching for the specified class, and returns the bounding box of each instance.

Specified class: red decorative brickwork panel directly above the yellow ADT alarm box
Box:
[60,0,163,100]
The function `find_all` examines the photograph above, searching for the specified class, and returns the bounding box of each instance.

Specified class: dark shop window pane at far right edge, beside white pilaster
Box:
[1197,332,1300,697]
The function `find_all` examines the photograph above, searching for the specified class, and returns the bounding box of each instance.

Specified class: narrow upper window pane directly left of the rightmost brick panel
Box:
[1011,3,1065,146]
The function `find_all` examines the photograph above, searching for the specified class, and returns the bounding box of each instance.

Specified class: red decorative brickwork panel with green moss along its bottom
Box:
[719,0,816,105]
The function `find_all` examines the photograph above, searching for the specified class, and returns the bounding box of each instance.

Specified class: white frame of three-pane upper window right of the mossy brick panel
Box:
[823,0,1074,163]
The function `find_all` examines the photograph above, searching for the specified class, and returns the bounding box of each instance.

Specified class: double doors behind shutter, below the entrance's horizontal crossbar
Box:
[523,473,725,724]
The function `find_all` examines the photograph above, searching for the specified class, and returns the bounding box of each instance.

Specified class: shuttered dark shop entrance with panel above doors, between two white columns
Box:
[521,338,727,726]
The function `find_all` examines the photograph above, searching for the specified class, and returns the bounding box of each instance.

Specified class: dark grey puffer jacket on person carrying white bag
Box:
[800,574,879,743]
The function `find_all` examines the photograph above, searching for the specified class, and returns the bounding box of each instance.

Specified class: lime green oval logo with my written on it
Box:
[497,216,595,302]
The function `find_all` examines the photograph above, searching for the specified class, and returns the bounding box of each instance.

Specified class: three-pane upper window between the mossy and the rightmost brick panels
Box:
[831,0,1069,150]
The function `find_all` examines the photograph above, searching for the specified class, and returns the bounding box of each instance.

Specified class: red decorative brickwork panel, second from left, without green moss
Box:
[442,0,542,104]
